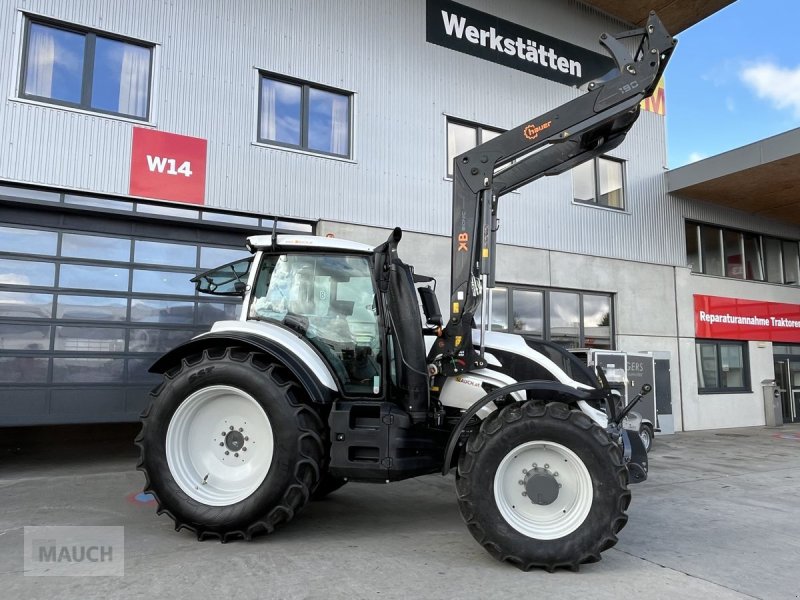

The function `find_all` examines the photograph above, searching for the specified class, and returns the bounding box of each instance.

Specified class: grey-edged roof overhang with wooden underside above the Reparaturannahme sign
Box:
[667,128,800,225]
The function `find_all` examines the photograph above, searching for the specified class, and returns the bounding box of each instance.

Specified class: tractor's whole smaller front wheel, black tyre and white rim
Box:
[456,401,631,571]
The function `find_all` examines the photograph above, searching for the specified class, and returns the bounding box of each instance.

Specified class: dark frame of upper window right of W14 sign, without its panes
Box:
[256,69,355,160]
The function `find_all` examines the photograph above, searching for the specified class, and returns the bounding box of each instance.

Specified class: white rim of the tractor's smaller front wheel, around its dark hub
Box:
[494,440,594,540]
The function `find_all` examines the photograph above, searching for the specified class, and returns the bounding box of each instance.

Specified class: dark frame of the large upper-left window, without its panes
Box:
[17,13,156,123]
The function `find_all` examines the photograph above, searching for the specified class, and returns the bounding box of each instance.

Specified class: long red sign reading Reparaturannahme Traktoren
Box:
[694,294,800,343]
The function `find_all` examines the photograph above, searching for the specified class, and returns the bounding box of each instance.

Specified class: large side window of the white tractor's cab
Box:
[248,254,380,395]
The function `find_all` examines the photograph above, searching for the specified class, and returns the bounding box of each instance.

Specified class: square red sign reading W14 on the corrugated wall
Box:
[130,127,207,204]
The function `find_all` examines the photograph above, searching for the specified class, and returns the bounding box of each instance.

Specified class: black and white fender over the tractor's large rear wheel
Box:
[149,321,338,404]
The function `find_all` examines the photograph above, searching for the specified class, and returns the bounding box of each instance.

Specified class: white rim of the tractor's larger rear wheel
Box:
[166,385,275,506]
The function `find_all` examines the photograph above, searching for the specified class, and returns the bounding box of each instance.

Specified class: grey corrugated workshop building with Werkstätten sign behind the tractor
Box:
[0,0,800,431]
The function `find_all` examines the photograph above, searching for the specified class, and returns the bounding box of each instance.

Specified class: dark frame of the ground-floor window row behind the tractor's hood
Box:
[484,283,616,350]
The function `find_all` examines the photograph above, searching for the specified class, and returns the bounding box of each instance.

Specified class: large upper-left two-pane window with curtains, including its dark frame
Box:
[20,20,153,120]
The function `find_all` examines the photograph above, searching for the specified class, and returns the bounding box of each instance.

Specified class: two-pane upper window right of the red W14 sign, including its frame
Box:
[258,74,352,158]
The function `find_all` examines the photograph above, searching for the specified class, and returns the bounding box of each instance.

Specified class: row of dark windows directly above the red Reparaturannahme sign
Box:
[686,221,800,285]
